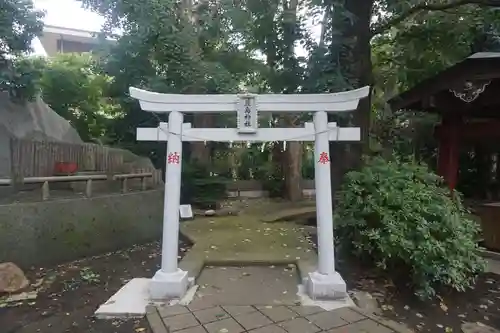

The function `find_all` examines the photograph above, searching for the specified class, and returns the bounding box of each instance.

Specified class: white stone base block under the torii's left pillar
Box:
[149,269,189,301]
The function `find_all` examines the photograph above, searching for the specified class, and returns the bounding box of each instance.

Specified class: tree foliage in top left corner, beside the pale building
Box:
[0,0,43,100]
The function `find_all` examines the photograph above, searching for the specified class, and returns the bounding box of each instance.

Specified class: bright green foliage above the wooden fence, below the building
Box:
[22,54,120,141]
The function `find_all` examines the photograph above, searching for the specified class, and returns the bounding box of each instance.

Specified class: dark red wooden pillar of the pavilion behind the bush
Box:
[436,115,462,190]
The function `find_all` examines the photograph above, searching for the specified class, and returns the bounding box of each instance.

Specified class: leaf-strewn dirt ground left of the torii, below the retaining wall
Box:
[0,238,191,333]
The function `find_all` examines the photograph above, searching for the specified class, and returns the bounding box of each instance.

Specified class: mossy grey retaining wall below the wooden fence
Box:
[0,190,163,268]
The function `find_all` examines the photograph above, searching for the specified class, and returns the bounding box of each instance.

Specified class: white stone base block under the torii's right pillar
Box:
[307,272,347,300]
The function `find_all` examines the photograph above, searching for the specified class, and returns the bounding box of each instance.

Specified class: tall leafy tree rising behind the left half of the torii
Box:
[78,0,256,166]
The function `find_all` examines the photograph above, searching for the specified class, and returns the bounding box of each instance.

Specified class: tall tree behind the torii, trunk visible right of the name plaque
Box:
[230,0,306,201]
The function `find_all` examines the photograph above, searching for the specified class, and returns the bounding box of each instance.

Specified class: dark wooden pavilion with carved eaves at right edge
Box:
[389,52,500,251]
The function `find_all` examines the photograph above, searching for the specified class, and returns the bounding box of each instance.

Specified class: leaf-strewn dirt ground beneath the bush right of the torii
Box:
[339,261,500,333]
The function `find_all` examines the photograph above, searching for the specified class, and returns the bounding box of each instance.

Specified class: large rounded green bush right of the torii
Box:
[335,157,484,298]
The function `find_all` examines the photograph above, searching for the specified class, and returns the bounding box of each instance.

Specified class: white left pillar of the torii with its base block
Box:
[149,111,189,300]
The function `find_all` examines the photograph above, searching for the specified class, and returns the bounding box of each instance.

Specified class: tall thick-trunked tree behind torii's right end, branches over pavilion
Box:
[308,0,500,195]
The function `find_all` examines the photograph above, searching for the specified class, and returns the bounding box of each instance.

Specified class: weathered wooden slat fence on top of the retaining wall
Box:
[10,139,123,179]
